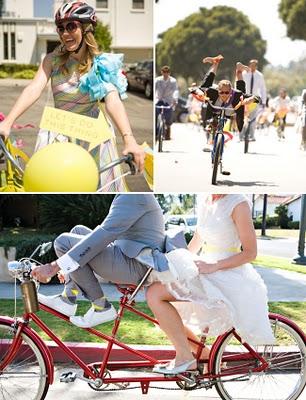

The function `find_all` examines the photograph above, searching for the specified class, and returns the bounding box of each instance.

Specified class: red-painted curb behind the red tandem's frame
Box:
[45,341,175,363]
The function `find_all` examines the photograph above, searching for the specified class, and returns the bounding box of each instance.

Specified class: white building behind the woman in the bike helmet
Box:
[0,0,153,64]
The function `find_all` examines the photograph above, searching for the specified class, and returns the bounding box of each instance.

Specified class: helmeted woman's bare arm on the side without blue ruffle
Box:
[0,54,52,137]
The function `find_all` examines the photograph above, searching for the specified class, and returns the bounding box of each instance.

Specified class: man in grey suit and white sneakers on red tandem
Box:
[32,194,168,327]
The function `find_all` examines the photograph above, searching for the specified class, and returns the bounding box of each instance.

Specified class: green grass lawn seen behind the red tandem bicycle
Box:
[0,299,306,345]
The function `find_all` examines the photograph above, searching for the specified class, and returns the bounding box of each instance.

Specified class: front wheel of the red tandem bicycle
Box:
[0,321,49,400]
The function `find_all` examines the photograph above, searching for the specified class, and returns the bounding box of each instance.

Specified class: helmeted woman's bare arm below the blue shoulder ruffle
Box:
[105,90,144,172]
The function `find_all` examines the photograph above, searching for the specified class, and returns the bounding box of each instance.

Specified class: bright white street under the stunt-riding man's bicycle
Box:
[155,123,306,193]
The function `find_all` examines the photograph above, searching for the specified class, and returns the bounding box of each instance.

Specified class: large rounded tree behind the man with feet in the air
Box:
[156,6,266,81]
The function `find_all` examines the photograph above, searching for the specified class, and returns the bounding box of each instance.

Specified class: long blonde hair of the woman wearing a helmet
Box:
[56,24,102,75]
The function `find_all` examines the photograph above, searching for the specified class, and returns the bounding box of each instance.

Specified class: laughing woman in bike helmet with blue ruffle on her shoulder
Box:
[0,1,144,191]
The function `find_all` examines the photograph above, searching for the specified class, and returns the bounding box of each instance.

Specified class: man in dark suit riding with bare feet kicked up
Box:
[200,55,260,131]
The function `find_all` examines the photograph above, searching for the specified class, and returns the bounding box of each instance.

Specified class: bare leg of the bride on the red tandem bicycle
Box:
[147,282,196,367]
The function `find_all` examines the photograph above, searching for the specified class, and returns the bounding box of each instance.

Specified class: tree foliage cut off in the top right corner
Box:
[278,0,306,40]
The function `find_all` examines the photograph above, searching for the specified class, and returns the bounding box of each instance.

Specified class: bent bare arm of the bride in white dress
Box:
[196,202,257,274]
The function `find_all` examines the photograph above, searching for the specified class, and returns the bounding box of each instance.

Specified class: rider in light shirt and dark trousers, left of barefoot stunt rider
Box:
[155,65,178,140]
